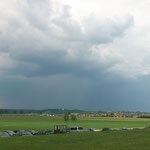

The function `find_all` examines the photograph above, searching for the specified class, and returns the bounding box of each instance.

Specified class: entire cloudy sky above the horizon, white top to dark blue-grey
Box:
[0,0,150,112]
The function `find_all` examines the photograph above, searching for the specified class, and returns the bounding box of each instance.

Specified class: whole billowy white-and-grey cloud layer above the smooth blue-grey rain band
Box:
[0,0,150,78]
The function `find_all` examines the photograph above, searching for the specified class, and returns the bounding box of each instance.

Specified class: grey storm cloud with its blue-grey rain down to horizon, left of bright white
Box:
[0,0,149,110]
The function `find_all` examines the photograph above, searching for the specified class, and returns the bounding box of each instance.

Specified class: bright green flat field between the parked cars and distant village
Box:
[0,115,150,131]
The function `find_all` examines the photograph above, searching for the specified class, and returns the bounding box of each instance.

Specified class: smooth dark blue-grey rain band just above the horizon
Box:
[0,75,150,111]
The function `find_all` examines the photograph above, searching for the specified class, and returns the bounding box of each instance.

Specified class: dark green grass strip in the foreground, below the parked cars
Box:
[0,129,150,150]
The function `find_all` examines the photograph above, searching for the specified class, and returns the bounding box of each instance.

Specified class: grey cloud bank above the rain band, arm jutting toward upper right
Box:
[0,0,133,76]
